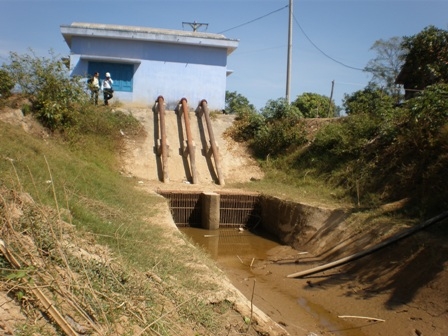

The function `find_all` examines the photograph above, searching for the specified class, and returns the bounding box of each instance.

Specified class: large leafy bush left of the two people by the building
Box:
[4,51,88,130]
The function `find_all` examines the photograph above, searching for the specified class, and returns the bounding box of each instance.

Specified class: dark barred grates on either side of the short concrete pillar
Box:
[158,190,261,228]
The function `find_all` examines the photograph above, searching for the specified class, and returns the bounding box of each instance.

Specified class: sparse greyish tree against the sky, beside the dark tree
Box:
[364,37,406,102]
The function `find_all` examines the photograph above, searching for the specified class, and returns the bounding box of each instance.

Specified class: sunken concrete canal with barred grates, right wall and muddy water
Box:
[163,192,372,336]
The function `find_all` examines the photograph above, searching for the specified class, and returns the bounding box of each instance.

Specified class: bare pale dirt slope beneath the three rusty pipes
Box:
[122,108,263,188]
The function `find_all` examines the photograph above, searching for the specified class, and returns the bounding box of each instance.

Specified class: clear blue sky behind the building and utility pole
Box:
[0,0,448,108]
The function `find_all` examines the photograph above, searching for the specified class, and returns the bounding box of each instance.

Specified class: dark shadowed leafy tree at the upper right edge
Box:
[397,26,448,99]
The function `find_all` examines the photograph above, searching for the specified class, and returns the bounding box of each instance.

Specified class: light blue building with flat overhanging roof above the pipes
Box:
[60,22,239,110]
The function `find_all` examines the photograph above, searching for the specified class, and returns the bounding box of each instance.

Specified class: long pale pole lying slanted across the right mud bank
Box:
[287,211,448,278]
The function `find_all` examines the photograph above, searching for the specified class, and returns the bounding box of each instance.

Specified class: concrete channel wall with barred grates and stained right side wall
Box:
[159,191,348,252]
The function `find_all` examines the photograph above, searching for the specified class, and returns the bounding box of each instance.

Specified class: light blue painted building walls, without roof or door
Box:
[70,37,227,110]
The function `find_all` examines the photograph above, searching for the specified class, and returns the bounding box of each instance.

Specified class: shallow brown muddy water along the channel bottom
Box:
[181,228,365,336]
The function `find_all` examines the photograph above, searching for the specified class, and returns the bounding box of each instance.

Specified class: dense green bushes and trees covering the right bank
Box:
[229,27,448,217]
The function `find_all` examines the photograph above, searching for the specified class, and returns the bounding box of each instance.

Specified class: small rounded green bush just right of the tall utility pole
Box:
[292,92,336,118]
